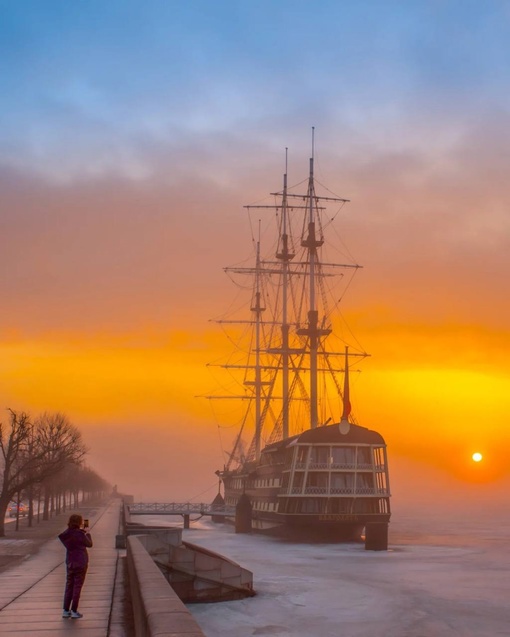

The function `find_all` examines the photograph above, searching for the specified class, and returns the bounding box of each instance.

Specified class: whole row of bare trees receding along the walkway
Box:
[0,409,108,537]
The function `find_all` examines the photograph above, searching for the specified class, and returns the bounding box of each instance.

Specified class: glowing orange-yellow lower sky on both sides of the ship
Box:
[0,280,510,499]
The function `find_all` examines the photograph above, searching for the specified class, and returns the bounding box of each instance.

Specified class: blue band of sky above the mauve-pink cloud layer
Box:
[0,0,510,178]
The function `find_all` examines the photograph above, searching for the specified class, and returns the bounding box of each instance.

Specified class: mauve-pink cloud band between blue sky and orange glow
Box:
[0,102,510,338]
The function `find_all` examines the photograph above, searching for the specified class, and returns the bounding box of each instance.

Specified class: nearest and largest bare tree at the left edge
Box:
[0,409,86,537]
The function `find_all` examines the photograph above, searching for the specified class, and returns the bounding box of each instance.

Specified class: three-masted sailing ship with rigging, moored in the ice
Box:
[211,133,390,550]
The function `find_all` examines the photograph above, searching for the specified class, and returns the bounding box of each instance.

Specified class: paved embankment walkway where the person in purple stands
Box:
[0,500,127,637]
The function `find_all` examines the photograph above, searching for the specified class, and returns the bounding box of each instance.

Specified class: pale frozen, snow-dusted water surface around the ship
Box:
[141,502,510,637]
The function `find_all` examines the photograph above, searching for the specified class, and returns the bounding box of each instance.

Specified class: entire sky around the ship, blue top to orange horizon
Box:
[0,0,510,496]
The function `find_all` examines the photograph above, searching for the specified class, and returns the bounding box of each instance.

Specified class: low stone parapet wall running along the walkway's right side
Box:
[127,535,204,637]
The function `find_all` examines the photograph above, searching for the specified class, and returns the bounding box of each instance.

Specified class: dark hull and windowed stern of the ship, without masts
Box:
[219,423,390,548]
